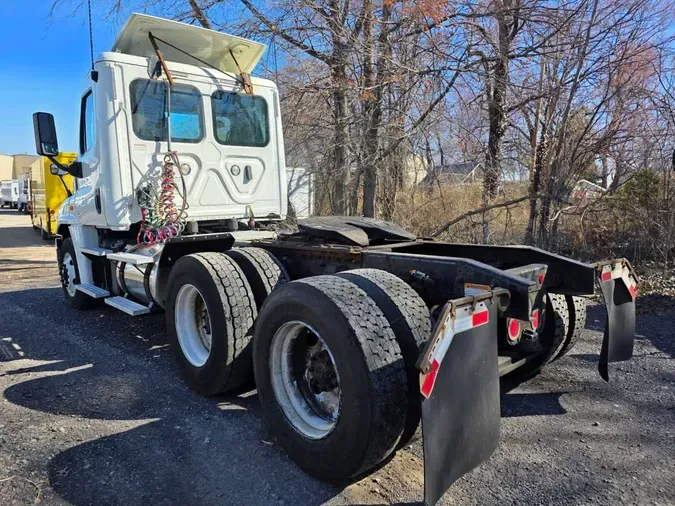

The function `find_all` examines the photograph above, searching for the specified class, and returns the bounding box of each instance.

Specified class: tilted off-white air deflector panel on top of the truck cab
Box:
[112,14,265,74]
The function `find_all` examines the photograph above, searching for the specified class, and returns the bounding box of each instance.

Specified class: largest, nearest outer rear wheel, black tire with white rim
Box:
[253,276,408,483]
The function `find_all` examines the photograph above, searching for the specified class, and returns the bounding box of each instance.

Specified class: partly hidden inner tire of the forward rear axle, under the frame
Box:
[225,248,290,310]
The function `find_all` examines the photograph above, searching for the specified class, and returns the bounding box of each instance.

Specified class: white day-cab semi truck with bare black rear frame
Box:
[34,14,637,504]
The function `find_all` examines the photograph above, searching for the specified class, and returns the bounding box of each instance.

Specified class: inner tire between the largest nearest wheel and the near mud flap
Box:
[338,269,431,448]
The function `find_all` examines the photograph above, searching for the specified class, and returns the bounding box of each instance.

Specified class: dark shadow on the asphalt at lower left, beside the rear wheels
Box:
[5,354,339,505]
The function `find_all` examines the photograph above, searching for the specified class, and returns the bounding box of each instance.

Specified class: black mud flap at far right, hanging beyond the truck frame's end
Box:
[598,259,638,381]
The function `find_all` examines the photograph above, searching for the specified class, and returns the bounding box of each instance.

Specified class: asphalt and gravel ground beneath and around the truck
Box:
[0,210,675,505]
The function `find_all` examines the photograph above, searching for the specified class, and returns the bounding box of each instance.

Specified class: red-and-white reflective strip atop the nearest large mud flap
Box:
[420,302,490,399]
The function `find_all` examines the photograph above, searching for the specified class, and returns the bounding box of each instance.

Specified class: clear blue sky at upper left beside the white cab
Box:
[0,0,120,154]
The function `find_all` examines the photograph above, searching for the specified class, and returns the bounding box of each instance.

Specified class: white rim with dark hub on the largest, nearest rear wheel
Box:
[269,321,342,439]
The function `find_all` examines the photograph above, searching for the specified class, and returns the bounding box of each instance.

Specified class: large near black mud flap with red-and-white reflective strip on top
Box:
[418,294,500,506]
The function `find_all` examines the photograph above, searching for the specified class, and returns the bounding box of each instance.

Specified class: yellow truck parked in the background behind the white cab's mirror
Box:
[30,153,77,240]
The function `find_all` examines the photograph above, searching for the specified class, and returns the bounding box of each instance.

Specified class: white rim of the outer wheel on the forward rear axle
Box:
[174,284,212,367]
